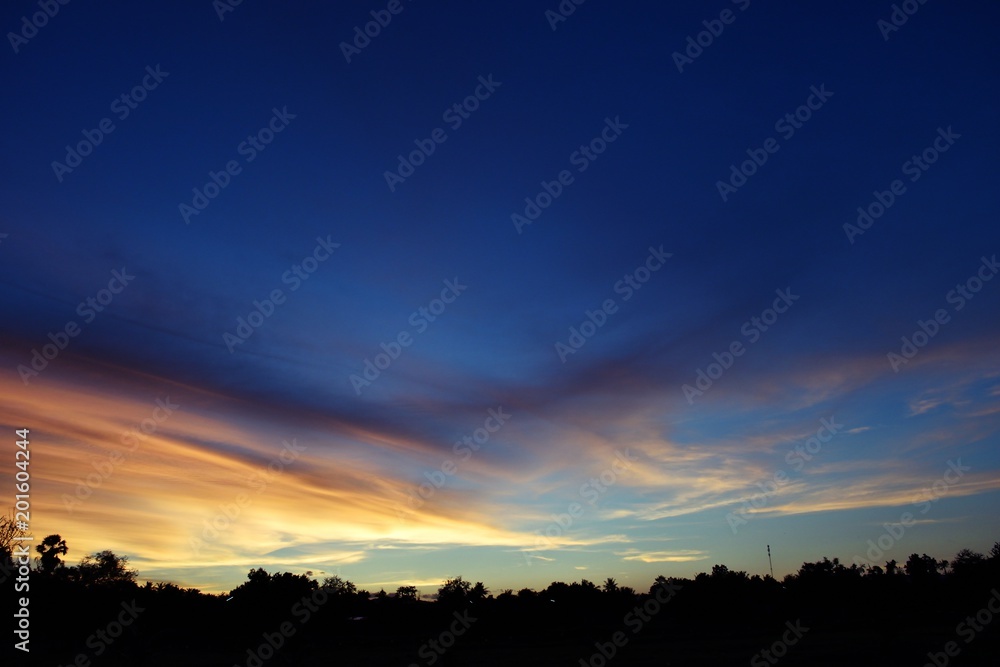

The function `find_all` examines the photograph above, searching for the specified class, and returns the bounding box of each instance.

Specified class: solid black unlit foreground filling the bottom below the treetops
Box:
[3,560,1000,667]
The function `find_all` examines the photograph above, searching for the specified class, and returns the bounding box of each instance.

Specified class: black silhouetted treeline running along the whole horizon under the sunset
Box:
[0,535,1000,667]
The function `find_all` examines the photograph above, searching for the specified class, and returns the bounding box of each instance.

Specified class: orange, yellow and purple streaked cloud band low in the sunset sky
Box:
[0,326,1000,590]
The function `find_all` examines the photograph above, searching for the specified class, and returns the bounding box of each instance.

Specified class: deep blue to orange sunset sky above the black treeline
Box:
[0,0,1000,594]
